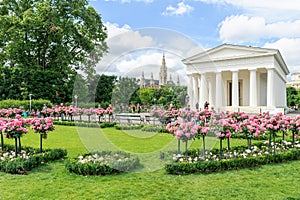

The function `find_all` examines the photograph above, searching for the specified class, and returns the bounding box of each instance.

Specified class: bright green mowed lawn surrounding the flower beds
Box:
[0,126,300,200]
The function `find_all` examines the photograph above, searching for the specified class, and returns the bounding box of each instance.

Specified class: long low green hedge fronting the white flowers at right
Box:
[165,149,300,174]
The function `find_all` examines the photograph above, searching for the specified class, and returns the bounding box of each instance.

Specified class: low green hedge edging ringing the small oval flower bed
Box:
[66,151,140,176]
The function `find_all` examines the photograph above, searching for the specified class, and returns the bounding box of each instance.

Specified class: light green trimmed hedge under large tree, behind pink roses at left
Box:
[0,99,52,110]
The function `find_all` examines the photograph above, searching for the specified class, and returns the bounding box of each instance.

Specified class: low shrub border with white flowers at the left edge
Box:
[0,145,67,174]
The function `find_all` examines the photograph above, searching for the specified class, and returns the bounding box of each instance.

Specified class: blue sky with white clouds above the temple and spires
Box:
[89,0,300,84]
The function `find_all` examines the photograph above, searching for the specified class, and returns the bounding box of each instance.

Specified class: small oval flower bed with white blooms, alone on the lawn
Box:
[66,151,140,175]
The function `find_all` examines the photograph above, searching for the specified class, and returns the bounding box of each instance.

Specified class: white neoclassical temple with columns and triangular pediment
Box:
[183,44,289,113]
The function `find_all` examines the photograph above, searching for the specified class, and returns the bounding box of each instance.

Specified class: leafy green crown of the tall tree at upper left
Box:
[0,0,107,72]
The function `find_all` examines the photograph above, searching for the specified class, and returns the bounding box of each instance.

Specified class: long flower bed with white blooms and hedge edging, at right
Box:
[165,141,300,174]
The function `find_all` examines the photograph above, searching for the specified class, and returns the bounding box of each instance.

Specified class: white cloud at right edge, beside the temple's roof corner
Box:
[264,38,300,72]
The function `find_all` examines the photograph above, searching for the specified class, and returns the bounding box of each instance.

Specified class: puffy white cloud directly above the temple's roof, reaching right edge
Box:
[219,15,300,43]
